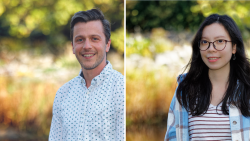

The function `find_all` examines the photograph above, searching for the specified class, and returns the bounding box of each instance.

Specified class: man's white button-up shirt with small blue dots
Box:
[49,61,125,141]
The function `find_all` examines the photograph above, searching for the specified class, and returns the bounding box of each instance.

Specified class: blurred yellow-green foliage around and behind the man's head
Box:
[0,0,124,56]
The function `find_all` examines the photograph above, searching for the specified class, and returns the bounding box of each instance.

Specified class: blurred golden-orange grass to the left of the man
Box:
[0,76,59,136]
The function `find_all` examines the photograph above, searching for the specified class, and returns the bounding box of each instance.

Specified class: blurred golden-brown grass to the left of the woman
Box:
[126,68,177,126]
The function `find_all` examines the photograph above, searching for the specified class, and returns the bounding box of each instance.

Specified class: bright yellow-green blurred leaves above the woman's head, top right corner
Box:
[193,0,250,40]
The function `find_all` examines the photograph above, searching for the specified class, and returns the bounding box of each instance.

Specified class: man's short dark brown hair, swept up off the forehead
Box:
[70,9,111,44]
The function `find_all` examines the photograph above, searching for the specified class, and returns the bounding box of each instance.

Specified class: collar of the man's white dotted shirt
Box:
[78,60,112,86]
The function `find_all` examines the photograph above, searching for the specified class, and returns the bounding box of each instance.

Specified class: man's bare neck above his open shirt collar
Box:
[82,61,107,88]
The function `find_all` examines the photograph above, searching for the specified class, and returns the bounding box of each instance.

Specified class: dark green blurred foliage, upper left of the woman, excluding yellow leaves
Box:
[126,1,204,32]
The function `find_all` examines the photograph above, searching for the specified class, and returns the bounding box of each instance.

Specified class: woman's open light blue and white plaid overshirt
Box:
[165,74,250,141]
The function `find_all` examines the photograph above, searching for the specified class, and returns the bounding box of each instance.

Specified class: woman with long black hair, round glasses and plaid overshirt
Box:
[165,14,250,141]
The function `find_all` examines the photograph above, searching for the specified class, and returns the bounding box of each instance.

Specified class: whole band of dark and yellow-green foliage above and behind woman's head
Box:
[126,0,250,39]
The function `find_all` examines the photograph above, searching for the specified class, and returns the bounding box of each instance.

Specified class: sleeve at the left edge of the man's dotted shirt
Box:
[49,89,63,141]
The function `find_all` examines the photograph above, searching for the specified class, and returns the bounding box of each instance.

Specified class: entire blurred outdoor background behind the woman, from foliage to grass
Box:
[126,0,250,141]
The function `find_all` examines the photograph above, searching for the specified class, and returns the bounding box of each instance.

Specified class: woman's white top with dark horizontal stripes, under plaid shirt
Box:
[188,104,232,141]
